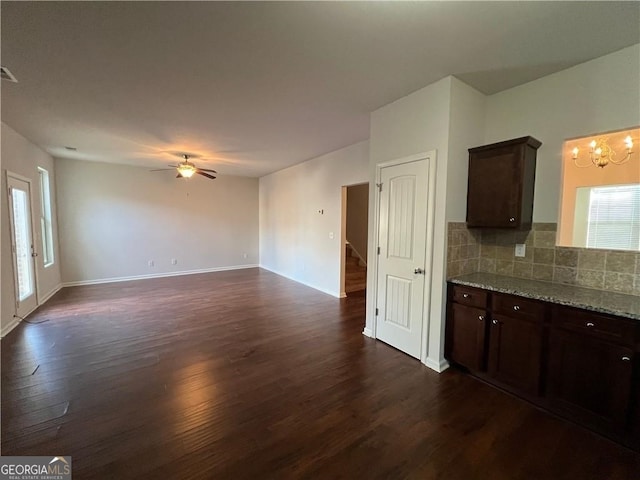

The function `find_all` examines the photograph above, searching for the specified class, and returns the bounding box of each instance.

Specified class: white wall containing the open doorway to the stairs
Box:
[260,142,369,296]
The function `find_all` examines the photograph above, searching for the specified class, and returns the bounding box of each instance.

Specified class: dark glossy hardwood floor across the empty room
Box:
[2,269,640,480]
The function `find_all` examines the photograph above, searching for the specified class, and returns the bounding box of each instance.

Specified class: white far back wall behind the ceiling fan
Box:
[56,159,258,284]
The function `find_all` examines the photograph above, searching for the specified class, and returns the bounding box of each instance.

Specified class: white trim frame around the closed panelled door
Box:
[367,150,436,364]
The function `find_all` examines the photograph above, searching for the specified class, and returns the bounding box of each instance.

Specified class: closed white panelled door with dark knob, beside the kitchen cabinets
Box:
[376,159,431,358]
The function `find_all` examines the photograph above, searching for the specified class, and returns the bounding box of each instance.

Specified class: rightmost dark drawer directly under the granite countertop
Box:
[552,307,635,345]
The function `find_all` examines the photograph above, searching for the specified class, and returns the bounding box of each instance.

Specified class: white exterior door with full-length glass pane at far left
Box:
[7,174,38,317]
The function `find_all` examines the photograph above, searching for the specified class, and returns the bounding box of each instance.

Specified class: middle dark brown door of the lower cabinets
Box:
[488,314,542,395]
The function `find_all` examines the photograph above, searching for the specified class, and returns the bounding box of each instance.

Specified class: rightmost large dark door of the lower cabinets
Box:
[548,329,633,431]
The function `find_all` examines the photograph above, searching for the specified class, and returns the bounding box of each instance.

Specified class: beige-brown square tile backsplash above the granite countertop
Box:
[447,222,640,296]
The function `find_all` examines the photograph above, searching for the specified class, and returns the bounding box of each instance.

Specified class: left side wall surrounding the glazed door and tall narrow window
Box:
[0,123,61,336]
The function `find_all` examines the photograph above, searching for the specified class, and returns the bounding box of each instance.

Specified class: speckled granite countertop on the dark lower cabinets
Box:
[449,273,640,320]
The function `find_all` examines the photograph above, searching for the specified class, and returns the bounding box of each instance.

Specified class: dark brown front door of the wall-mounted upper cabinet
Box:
[467,146,523,228]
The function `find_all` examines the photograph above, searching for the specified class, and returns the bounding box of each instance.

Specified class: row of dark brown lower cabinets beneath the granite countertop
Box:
[445,284,640,450]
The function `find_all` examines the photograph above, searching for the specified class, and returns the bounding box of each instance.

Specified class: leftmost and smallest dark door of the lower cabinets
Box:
[448,303,486,371]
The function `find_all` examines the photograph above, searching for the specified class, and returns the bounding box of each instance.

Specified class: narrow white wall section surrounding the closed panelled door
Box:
[365,77,452,370]
